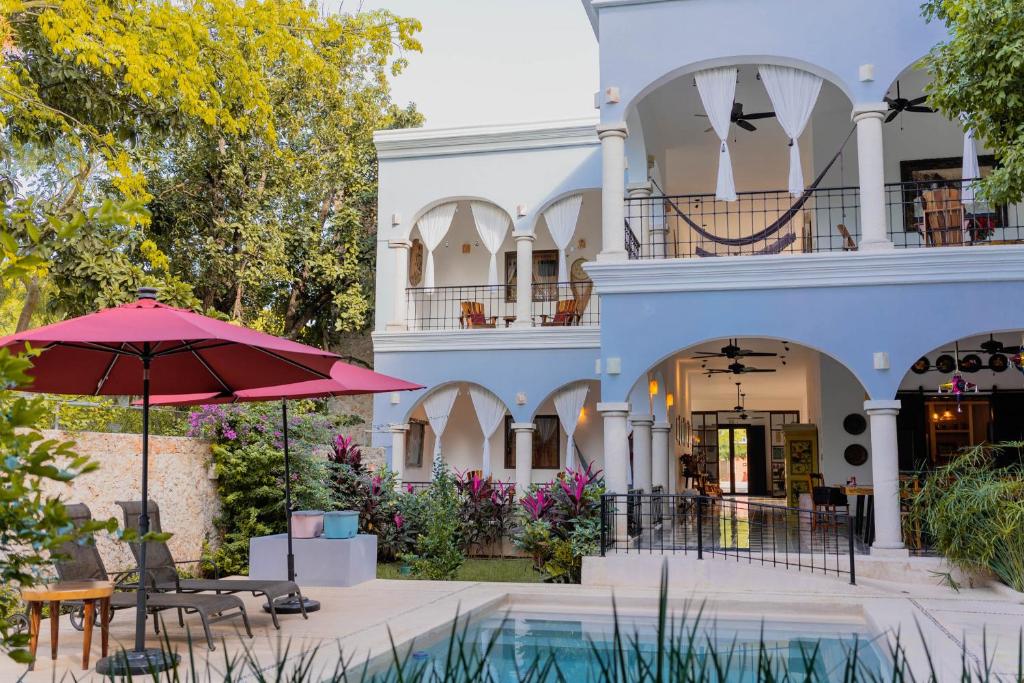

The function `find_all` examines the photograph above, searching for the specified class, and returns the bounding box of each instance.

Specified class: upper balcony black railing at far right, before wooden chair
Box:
[886,178,1024,248]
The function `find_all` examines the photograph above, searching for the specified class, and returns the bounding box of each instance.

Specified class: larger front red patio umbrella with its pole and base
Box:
[0,288,337,675]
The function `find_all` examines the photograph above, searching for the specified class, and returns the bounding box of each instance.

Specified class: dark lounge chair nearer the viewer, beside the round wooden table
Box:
[56,504,253,650]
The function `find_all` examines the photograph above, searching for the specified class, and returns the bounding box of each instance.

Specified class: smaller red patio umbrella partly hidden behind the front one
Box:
[142,360,426,614]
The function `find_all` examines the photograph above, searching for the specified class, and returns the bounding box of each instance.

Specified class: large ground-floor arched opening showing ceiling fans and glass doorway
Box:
[630,338,871,507]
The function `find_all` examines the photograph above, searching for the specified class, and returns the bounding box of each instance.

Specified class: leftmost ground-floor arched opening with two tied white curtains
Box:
[392,382,515,483]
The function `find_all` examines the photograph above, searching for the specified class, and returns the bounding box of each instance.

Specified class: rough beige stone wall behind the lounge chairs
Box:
[43,430,219,571]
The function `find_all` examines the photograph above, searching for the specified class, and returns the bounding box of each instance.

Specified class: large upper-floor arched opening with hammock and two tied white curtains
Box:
[627,59,859,258]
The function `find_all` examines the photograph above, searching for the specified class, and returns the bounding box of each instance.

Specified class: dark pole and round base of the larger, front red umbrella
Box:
[96,352,180,676]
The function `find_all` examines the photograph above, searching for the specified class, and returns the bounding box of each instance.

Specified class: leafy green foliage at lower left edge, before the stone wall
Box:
[0,350,117,661]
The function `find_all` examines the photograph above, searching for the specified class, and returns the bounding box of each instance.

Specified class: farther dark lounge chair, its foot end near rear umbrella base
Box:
[117,501,309,629]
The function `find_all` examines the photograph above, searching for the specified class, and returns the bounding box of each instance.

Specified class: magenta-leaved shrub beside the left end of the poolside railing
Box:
[513,465,604,584]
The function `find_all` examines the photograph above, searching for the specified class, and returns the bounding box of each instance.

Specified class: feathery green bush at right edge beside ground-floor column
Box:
[913,442,1024,591]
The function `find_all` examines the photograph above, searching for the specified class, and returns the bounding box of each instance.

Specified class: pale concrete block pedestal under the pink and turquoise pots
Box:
[249,533,377,589]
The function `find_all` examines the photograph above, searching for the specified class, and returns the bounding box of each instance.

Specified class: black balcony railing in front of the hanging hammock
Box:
[626,187,860,258]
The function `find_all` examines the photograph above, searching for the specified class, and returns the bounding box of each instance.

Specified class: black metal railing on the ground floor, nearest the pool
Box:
[601,492,856,584]
